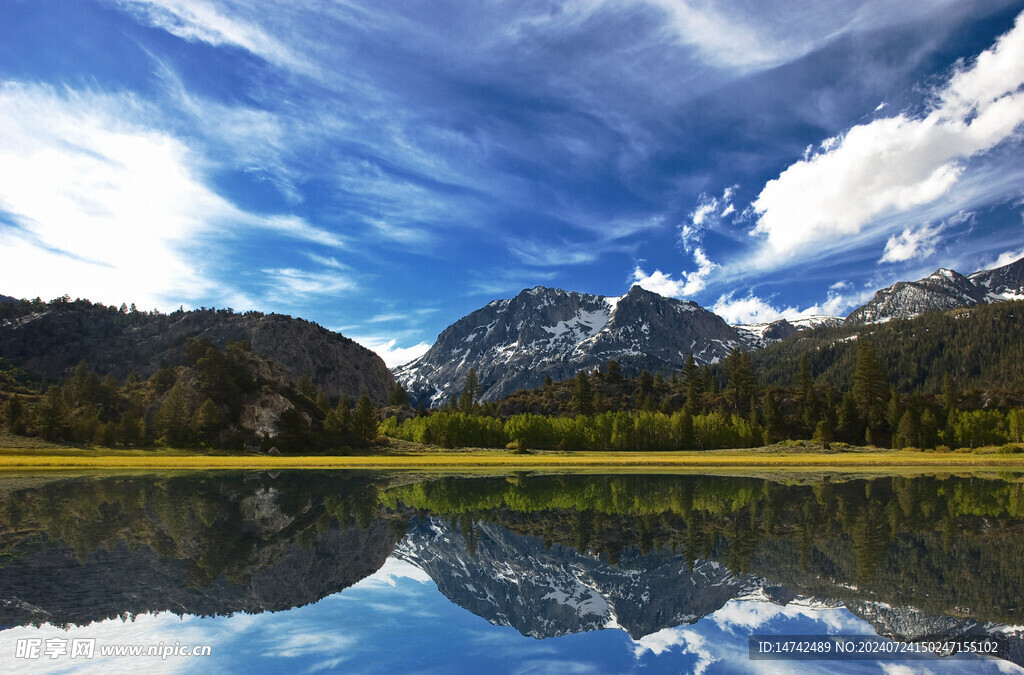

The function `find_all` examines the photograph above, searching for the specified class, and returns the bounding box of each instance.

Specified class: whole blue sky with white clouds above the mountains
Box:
[0,0,1024,366]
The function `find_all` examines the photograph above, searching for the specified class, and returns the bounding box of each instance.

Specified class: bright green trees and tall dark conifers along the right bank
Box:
[380,338,1024,452]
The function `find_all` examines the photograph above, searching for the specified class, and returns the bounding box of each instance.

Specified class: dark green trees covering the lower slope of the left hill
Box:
[0,338,387,453]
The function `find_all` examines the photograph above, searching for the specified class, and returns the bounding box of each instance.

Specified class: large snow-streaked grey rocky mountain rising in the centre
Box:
[395,286,744,405]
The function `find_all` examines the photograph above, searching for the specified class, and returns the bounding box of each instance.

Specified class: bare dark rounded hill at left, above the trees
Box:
[0,301,394,404]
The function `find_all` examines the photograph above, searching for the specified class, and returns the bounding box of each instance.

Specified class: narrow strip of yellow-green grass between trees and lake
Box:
[0,441,1024,473]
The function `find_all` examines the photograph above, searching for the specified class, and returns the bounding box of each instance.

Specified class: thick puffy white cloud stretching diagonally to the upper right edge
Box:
[751,14,1024,266]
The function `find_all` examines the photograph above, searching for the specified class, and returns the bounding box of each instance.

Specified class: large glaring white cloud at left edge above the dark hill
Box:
[0,82,343,309]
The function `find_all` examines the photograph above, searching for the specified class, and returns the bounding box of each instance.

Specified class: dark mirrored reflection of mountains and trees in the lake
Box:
[0,472,1024,667]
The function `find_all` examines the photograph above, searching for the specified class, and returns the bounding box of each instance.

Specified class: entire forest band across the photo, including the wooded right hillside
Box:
[0,302,1024,454]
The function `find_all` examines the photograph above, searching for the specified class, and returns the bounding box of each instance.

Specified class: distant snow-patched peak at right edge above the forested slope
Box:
[846,258,1024,326]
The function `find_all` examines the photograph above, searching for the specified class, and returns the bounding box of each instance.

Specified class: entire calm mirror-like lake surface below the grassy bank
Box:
[0,472,1024,673]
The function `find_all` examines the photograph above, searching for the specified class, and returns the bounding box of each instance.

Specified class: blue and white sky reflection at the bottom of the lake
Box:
[0,558,1021,675]
